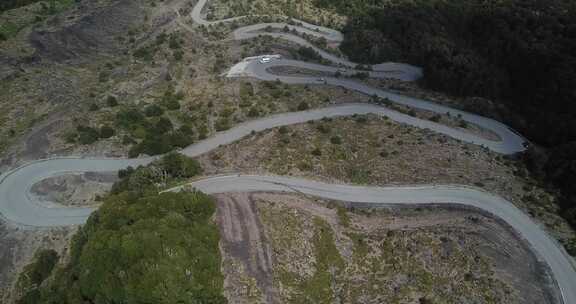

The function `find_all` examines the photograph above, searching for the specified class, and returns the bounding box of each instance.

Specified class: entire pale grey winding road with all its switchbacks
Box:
[0,0,576,304]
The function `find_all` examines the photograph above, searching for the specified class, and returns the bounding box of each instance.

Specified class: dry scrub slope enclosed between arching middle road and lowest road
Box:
[200,115,576,254]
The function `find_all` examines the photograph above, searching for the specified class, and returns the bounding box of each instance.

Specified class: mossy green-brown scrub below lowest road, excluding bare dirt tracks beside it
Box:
[257,196,516,303]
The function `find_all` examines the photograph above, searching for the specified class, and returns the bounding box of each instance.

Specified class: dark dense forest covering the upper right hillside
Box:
[316,0,576,232]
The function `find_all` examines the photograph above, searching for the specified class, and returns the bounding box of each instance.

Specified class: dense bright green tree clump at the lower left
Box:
[21,154,226,304]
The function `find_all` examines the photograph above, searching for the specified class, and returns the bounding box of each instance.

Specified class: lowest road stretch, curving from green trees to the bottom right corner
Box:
[180,175,576,304]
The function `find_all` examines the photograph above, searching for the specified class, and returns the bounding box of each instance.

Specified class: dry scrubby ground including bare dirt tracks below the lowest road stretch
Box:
[217,193,558,304]
